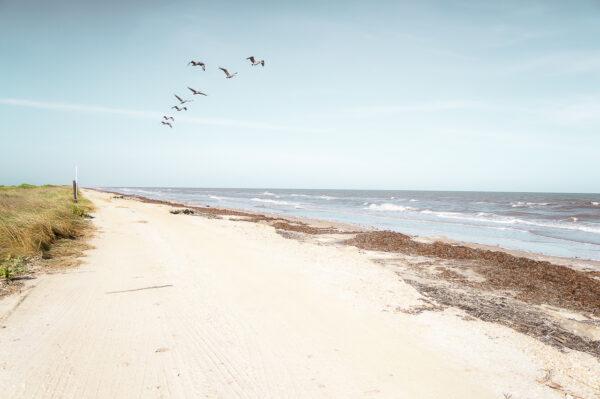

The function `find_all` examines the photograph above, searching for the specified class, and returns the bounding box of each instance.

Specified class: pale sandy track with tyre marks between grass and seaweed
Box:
[0,192,568,399]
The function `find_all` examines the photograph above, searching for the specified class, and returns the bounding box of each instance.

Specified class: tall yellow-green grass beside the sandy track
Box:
[0,184,92,262]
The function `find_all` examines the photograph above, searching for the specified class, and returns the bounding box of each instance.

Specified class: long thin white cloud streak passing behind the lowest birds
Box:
[0,98,326,133]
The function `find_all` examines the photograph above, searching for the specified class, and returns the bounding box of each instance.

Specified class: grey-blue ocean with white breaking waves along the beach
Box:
[104,187,600,260]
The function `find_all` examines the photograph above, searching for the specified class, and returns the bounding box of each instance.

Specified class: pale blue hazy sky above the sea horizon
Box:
[0,0,600,193]
